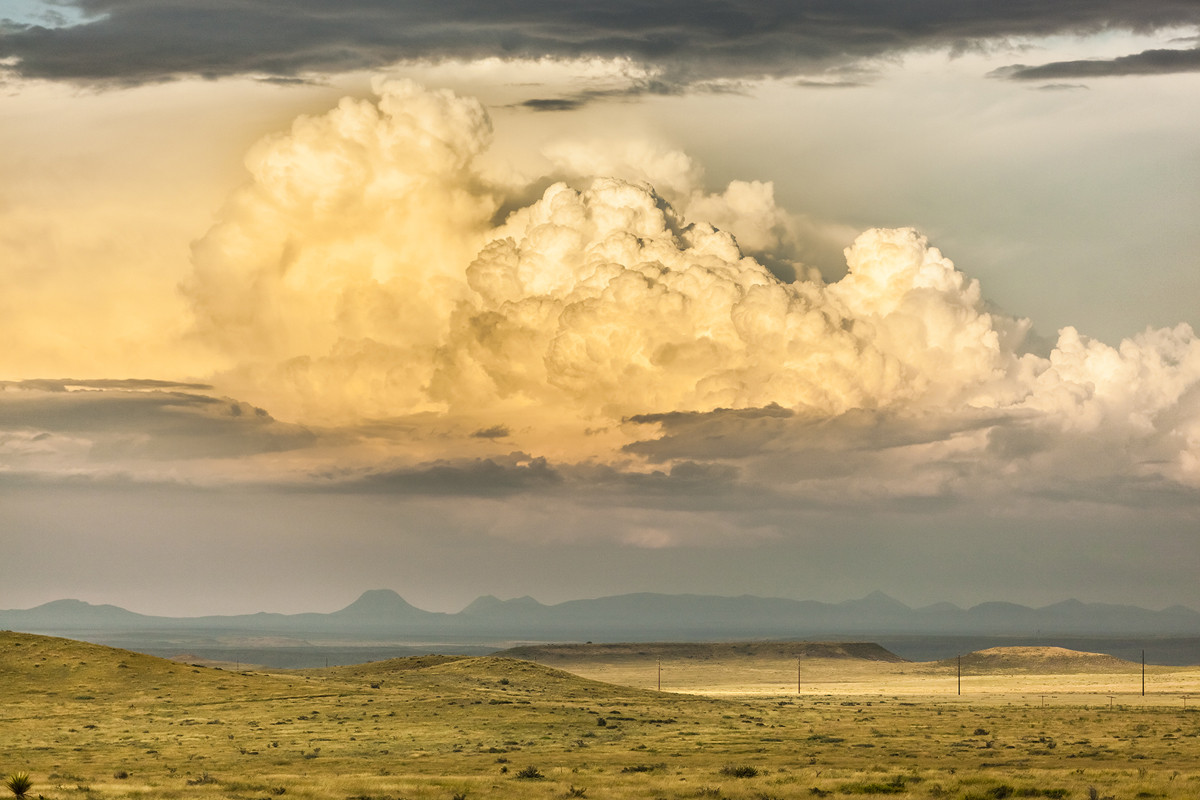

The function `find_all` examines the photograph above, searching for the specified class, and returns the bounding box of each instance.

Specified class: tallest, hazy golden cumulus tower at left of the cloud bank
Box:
[187,77,497,420]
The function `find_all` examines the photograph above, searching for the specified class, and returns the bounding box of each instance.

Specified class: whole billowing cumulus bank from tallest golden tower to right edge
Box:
[175,83,1200,495]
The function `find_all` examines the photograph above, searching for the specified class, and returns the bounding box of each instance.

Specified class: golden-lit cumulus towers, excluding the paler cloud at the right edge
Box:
[188,83,1022,426]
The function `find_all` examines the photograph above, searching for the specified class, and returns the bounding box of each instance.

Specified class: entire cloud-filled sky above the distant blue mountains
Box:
[0,0,1200,615]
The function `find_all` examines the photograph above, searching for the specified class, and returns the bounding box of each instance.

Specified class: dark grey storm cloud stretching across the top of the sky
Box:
[0,0,1200,84]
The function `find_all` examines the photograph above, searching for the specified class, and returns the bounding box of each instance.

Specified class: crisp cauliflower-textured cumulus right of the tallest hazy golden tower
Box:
[436,179,1019,417]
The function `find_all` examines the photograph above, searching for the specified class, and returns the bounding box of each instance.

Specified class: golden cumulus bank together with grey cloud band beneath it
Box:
[0,82,1200,525]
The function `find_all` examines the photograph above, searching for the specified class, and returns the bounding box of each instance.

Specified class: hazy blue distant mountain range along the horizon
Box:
[0,589,1200,643]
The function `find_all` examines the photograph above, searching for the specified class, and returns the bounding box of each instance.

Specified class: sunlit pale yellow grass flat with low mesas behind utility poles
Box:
[504,642,1200,708]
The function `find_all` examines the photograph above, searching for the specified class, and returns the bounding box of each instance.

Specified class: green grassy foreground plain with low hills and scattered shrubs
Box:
[0,633,1200,800]
